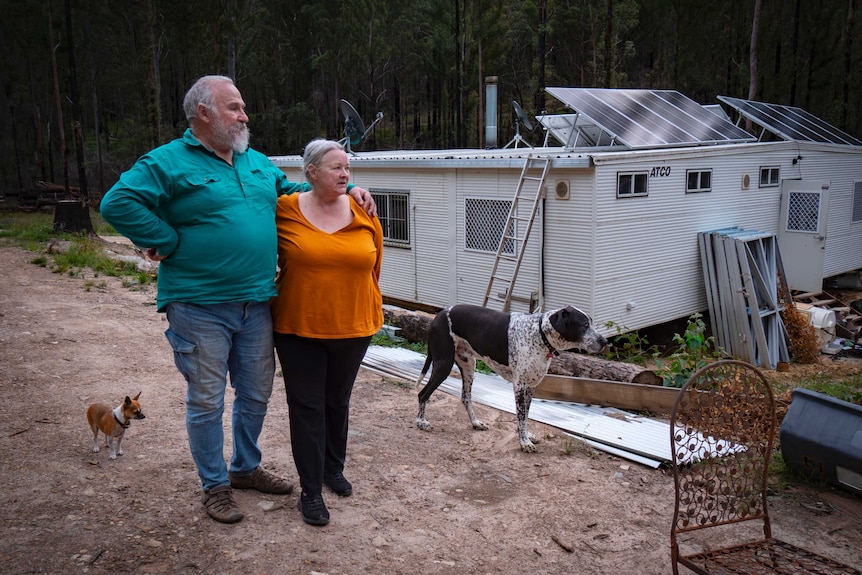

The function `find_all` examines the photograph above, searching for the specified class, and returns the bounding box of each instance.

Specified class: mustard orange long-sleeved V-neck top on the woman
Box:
[272,194,383,339]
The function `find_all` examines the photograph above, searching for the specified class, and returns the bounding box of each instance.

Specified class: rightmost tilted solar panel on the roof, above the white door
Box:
[718,96,862,146]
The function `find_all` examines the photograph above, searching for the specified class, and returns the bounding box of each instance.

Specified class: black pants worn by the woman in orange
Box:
[275,333,371,495]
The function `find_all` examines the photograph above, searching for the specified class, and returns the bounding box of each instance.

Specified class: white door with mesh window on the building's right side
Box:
[778,180,829,293]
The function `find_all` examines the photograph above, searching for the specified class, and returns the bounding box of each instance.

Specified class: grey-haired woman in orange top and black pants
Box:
[272,139,383,525]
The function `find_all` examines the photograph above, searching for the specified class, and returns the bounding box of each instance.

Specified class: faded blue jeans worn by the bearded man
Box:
[165,302,275,490]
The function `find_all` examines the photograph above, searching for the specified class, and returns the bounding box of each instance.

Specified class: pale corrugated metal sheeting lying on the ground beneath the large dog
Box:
[362,346,671,468]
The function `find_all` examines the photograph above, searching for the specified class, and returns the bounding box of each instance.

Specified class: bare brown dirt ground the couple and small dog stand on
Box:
[0,245,862,575]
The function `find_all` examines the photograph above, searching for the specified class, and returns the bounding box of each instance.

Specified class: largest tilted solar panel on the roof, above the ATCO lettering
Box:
[546,87,755,148]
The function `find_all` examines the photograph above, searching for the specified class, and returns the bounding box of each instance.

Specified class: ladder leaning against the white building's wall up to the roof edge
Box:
[482,154,551,312]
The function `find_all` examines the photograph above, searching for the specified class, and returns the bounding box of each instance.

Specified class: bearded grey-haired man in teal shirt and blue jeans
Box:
[100,76,376,523]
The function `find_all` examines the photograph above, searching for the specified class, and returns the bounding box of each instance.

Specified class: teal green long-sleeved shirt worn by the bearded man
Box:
[100,129,309,311]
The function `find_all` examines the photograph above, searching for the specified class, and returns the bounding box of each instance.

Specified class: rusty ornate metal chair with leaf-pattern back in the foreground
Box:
[670,360,862,575]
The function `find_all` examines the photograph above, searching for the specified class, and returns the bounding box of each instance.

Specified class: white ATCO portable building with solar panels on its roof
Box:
[272,88,862,334]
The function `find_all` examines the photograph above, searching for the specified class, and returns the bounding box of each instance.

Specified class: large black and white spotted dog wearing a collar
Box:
[416,304,607,452]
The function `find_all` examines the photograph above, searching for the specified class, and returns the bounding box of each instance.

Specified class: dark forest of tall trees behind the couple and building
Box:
[0,0,862,203]
